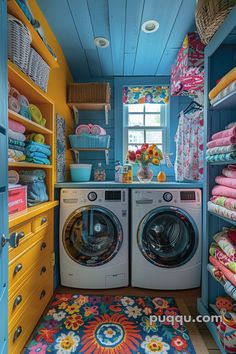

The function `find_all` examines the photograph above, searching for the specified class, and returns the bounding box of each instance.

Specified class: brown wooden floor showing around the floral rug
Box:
[56,287,220,354]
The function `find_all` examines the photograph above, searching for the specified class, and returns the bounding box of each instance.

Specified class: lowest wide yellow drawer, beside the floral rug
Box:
[8,279,53,354]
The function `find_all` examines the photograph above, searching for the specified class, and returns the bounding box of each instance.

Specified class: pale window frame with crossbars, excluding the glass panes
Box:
[123,103,170,159]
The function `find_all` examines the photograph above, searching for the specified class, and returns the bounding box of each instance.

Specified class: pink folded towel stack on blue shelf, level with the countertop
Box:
[208,165,236,220]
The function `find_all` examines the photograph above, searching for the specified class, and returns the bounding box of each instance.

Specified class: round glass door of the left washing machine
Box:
[62,206,123,267]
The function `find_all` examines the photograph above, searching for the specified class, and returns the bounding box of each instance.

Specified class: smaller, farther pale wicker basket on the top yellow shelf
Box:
[27,48,50,92]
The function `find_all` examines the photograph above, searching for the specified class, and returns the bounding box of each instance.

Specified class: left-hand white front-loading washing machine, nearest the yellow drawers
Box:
[60,189,129,289]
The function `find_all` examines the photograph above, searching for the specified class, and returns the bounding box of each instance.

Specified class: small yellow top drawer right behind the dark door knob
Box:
[9,219,33,261]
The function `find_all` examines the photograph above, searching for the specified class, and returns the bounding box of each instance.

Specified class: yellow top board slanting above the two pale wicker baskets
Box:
[7,0,59,69]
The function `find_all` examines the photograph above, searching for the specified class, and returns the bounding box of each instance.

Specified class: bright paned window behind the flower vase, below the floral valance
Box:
[124,103,168,157]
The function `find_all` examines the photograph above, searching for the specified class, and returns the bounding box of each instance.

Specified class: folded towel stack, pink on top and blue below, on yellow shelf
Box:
[8,119,26,162]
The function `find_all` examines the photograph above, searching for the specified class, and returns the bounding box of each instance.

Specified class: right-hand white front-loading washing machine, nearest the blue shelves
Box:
[131,189,202,290]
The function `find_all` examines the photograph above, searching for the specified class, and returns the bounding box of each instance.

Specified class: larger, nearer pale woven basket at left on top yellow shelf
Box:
[7,15,32,73]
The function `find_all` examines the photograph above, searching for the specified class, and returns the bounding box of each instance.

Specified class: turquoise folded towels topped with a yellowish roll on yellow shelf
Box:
[25,133,51,165]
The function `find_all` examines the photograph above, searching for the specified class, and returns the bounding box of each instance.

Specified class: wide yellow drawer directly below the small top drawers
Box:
[8,231,53,293]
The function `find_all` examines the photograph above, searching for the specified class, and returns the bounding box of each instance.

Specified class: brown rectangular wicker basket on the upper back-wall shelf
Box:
[68,82,110,104]
